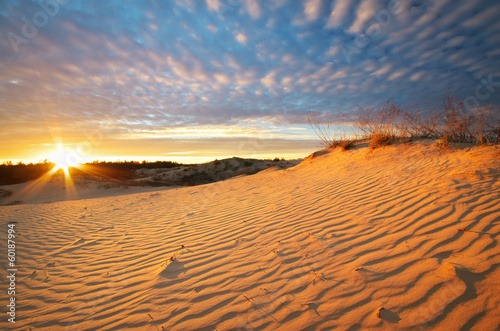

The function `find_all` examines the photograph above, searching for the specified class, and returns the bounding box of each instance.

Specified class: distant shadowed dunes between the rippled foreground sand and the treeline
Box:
[0,157,300,206]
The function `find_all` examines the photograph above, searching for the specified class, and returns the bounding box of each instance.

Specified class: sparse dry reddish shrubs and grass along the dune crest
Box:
[308,96,500,150]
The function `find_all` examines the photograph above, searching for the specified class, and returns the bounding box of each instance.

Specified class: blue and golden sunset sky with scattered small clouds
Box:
[0,0,500,162]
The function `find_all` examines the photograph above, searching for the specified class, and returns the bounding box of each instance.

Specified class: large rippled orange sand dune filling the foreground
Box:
[0,141,500,330]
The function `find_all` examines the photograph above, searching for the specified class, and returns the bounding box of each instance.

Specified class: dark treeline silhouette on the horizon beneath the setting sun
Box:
[0,160,184,185]
